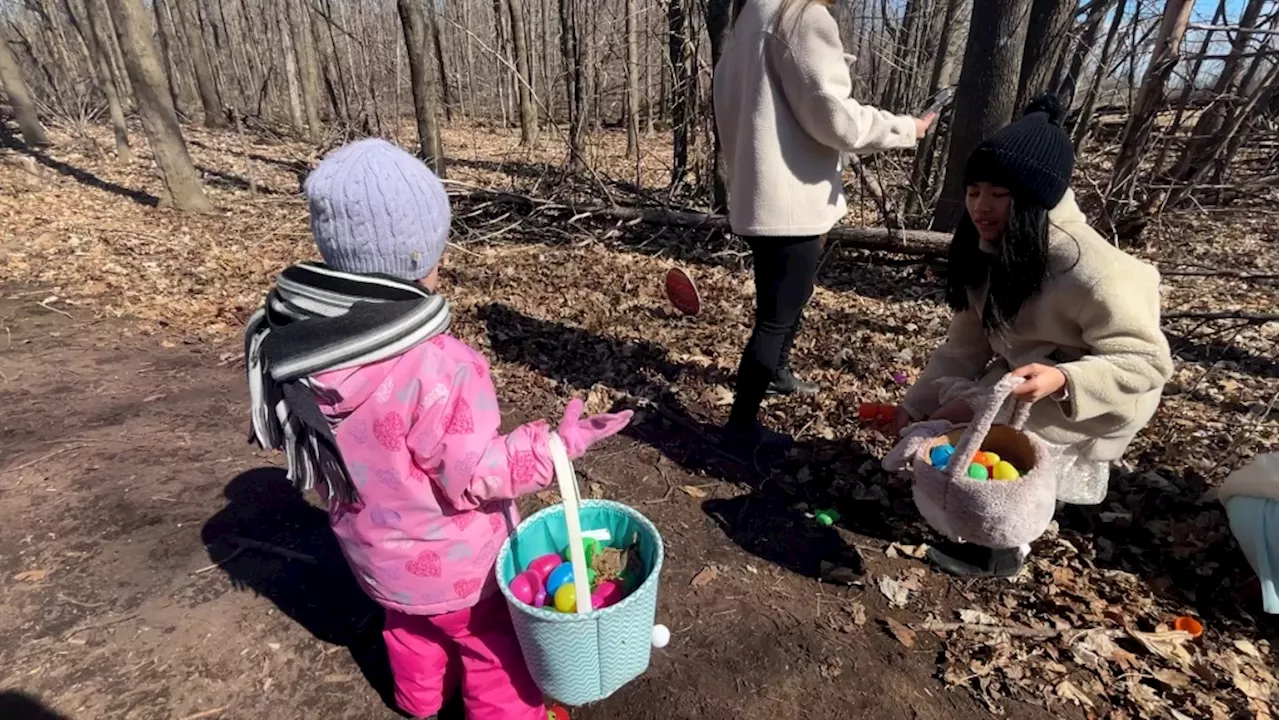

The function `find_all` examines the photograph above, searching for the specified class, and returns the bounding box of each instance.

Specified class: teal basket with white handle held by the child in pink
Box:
[495,430,664,706]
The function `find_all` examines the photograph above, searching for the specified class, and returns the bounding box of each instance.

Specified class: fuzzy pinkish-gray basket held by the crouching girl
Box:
[911,375,1057,548]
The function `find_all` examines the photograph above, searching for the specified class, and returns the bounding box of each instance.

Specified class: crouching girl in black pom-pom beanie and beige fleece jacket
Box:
[892,95,1172,577]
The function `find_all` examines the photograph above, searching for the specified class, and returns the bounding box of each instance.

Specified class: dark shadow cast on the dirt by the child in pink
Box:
[204,468,462,720]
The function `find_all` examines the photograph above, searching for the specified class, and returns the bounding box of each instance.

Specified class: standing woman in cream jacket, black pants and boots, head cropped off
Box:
[714,0,934,451]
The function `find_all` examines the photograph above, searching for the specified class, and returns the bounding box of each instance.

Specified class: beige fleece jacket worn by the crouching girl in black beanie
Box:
[902,192,1172,461]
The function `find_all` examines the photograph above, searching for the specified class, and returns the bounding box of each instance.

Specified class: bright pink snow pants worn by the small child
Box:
[383,593,547,720]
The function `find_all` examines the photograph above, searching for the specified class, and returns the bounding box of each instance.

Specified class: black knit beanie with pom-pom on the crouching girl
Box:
[964,94,1075,210]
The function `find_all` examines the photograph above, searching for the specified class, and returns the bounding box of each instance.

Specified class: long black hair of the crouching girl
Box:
[947,193,1050,332]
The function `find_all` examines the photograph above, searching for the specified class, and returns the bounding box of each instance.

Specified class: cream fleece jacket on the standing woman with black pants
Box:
[714,0,916,237]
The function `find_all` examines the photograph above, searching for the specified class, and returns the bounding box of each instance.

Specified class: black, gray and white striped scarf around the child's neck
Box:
[244,263,449,502]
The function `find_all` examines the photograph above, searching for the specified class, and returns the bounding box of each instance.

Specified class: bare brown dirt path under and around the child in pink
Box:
[0,288,1048,720]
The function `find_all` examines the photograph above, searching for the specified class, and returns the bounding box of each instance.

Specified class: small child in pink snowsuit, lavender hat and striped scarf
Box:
[247,140,631,720]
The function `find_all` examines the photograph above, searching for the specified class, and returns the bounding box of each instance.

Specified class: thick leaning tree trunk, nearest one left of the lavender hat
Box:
[108,0,214,210]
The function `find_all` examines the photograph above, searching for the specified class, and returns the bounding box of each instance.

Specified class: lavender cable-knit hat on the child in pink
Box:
[305,138,449,281]
